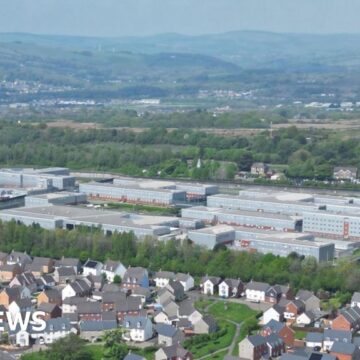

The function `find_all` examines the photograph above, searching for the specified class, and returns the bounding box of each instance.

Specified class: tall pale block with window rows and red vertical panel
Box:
[303,211,360,241]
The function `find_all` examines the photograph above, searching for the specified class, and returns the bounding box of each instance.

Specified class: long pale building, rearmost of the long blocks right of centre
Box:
[207,194,321,215]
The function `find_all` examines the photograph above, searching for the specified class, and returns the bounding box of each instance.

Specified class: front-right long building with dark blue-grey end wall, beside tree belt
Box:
[230,237,335,262]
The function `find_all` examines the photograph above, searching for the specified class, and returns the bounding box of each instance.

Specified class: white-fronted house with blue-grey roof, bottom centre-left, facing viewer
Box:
[122,315,153,342]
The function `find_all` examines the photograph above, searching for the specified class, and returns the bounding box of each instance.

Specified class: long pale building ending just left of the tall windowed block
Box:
[181,206,302,231]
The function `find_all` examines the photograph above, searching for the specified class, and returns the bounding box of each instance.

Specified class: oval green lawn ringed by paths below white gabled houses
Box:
[209,301,258,323]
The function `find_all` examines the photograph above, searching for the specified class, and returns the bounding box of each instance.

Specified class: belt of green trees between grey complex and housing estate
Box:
[0,222,360,301]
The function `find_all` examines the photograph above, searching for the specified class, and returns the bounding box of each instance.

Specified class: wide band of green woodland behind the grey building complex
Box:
[0,121,360,180]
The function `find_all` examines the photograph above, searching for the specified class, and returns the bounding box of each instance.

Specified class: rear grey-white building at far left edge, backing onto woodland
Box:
[0,168,75,191]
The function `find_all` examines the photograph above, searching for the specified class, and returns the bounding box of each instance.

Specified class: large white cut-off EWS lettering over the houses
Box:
[0,311,46,332]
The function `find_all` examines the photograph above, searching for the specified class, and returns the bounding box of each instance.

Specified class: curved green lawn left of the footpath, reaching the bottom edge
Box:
[186,320,236,359]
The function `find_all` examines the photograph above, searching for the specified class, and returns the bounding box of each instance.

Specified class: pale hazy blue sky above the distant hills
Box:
[0,0,360,37]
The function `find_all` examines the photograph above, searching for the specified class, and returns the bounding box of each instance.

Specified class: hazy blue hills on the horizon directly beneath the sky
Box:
[0,31,360,68]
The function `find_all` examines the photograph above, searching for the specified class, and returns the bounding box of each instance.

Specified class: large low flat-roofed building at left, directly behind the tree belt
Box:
[0,205,179,238]
